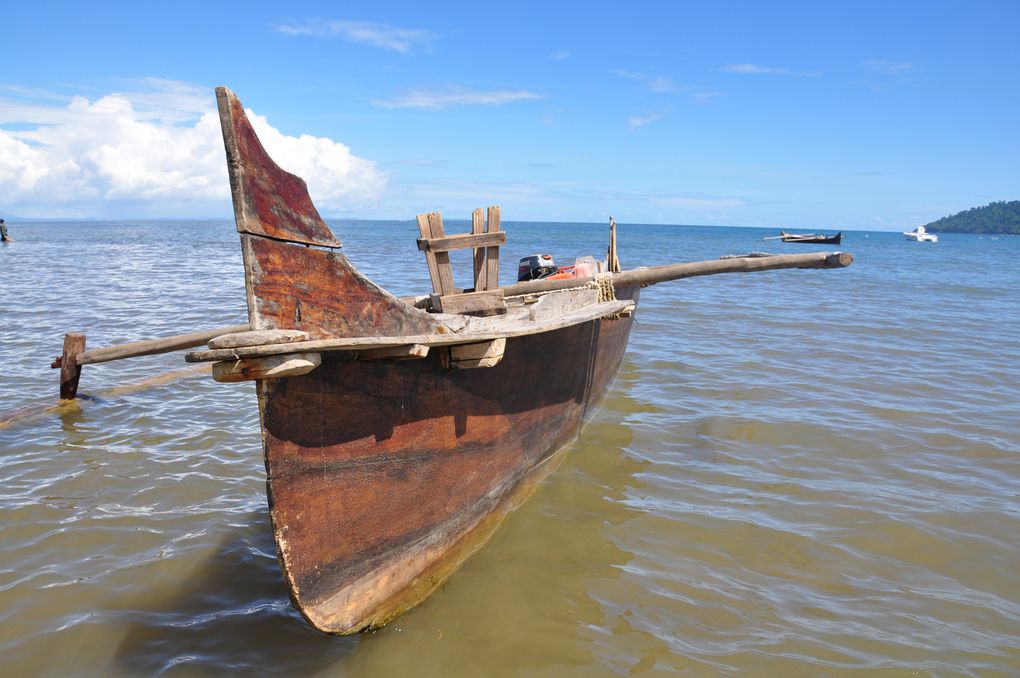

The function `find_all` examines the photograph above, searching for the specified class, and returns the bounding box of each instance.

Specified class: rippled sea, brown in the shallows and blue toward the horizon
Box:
[0,221,1020,677]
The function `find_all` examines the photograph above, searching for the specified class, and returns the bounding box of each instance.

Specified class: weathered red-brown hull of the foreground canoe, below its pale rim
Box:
[258,289,638,633]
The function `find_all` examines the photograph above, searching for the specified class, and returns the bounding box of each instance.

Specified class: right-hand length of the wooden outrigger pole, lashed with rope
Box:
[503,252,854,297]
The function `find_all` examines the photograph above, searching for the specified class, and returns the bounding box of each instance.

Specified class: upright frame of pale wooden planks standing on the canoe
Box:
[418,206,506,314]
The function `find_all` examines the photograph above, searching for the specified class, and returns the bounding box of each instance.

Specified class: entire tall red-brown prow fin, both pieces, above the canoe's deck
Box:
[216,87,439,340]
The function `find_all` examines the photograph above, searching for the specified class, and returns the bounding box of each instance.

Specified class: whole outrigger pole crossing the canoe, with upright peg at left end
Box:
[50,247,854,400]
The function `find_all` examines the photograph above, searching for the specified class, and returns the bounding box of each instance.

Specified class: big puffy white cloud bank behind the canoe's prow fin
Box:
[0,81,386,217]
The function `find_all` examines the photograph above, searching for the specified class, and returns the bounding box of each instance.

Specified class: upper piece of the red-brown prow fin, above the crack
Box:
[216,87,341,248]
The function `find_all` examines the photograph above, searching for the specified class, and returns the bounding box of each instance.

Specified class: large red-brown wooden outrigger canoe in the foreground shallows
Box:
[54,88,853,634]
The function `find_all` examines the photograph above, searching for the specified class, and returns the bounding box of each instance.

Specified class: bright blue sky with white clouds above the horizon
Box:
[0,0,1020,230]
